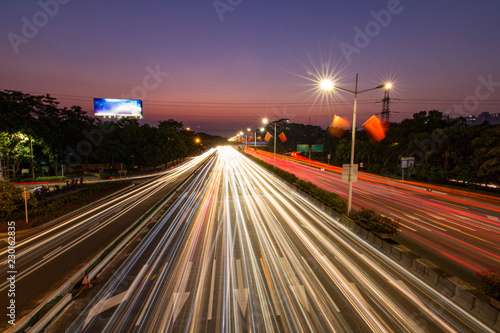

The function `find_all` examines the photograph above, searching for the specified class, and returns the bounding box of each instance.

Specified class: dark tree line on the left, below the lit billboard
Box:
[0,90,223,178]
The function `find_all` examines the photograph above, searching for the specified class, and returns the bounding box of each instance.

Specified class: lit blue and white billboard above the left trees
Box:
[94,98,142,119]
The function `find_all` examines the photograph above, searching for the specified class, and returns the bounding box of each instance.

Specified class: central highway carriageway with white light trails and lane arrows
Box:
[67,147,489,332]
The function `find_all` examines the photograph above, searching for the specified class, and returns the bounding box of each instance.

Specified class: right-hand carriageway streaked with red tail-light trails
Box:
[247,149,500,284]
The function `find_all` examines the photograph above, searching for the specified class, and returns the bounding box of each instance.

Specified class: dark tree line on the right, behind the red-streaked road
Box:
[262,110,500,185]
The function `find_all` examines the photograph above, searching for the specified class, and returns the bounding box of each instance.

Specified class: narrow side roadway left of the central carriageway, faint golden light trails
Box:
[0,151,213,330]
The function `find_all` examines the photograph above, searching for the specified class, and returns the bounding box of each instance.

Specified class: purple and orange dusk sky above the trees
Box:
[0,0,500,135]
